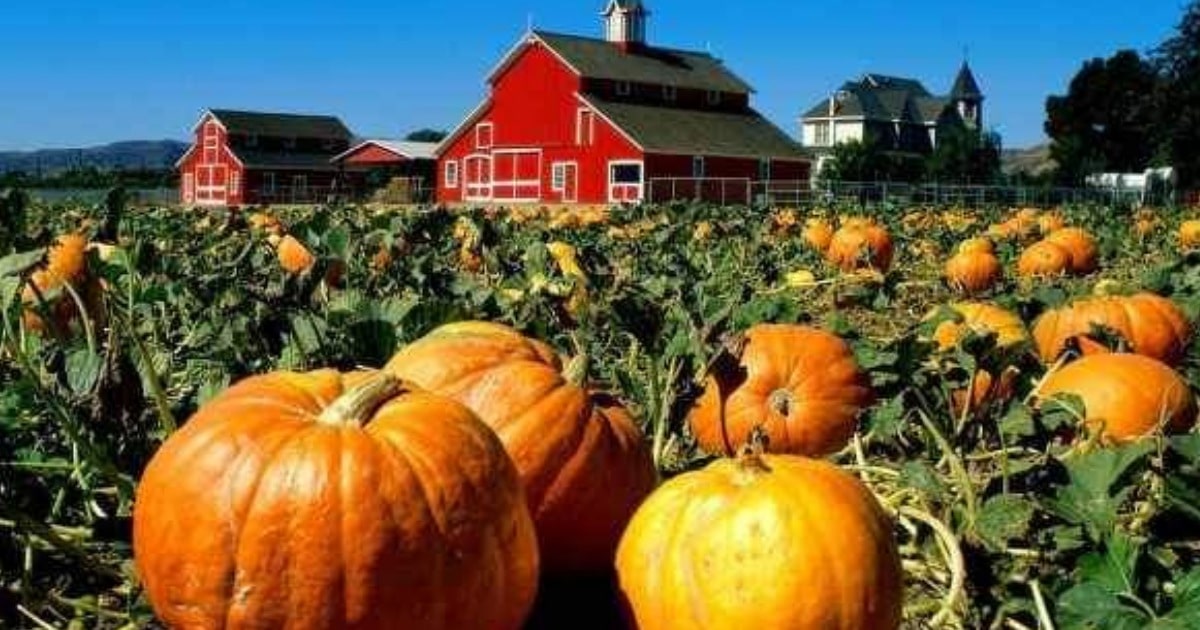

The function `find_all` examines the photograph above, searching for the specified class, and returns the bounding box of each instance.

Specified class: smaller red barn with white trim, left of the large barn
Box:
[175,109,352,205]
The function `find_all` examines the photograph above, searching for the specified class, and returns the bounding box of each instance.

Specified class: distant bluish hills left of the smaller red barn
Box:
[0,140,190,175]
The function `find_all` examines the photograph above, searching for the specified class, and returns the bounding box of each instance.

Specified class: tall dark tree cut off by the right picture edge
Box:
[1154,0,1200,186]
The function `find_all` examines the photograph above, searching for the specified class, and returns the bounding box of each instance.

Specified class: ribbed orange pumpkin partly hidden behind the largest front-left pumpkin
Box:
[385,322,656,572]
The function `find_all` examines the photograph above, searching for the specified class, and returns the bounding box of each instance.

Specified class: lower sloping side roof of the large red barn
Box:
[580,96,806,158]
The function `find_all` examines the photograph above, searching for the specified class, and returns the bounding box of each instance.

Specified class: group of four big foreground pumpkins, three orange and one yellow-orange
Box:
[133,322,902,630]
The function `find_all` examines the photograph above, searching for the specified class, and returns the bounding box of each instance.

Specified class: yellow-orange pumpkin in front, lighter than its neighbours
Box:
[617,455,902,630]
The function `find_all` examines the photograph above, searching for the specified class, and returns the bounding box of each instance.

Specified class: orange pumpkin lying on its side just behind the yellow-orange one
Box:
[688,324,874,457]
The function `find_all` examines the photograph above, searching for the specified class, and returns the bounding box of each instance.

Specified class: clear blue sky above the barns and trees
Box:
[0,0,1184,150]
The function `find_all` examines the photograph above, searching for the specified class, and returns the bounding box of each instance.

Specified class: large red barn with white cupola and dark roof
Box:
[438,0,810,204]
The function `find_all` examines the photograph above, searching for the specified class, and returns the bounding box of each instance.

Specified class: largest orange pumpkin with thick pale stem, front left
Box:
[133,371,538,630]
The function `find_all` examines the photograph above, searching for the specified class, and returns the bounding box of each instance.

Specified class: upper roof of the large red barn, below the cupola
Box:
[525,31,754,94]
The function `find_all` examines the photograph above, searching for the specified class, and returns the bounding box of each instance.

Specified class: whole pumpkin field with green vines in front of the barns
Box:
[0,193,1200,630]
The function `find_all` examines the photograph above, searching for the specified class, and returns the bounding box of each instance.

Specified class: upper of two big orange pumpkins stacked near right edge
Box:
[1033,293,1192,365]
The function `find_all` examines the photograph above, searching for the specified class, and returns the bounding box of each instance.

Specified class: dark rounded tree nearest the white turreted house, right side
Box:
[1045,50,1162,185]
